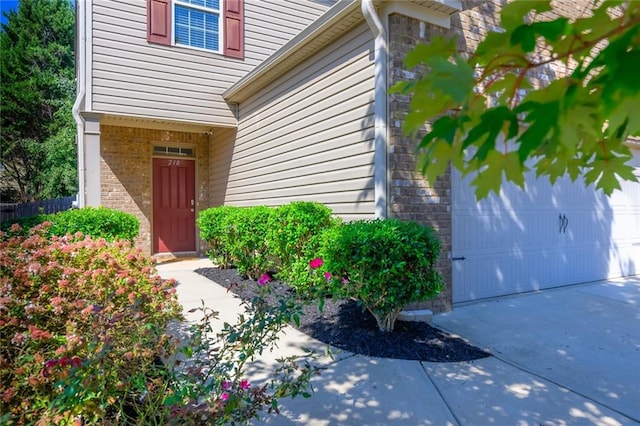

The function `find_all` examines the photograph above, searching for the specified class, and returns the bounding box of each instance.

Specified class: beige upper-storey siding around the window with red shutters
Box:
[91,0,328,126]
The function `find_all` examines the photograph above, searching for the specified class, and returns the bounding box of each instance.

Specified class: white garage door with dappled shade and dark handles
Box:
[451,151,640,303]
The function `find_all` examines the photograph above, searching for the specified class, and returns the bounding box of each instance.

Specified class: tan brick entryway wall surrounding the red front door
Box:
[100,126,210,254]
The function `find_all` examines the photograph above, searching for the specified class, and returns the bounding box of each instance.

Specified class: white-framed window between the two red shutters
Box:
[173,0,221,52]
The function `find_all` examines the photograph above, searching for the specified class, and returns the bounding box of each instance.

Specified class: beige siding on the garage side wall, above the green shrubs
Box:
[225,24,375,220]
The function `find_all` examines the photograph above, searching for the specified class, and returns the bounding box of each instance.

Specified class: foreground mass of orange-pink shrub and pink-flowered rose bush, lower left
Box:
[0,224,317,425]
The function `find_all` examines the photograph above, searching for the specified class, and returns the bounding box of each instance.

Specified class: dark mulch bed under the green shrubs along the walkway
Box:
[196,268,490,362]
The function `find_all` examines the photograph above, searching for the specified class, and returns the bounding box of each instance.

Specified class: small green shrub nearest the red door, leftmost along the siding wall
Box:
[196,206,240,269]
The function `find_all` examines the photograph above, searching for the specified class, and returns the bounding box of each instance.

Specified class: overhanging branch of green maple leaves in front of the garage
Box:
[393,0,640,198]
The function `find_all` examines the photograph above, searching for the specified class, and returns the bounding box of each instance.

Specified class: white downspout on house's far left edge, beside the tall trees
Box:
[71,1,86,208]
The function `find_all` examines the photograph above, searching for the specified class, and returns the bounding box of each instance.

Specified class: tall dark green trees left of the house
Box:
[0,0,76,202]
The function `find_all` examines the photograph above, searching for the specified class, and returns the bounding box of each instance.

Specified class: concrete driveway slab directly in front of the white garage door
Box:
[433,276,640,424]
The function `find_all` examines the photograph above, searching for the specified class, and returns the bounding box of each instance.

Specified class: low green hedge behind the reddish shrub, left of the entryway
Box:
[1,207,140,242]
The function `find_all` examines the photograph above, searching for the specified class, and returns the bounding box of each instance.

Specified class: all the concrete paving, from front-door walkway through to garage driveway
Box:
[158,259,640,426]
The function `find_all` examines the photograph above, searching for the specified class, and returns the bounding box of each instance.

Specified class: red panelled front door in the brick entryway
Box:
[153,158,196,253]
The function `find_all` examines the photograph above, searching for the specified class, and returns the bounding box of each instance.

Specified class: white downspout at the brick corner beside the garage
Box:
[361,0,388,218]
